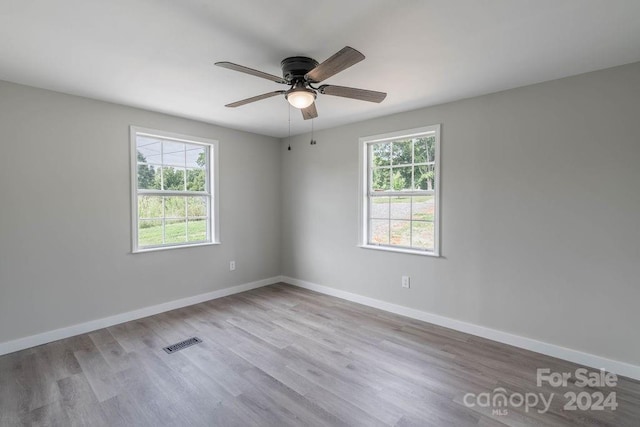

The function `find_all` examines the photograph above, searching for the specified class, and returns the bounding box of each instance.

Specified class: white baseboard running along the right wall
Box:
[281,276,640,380]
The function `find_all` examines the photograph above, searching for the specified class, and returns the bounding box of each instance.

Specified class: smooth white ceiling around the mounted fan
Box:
[0,0,640,137]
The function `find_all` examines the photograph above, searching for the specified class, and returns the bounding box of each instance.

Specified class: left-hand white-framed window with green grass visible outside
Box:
[131,126,218,252]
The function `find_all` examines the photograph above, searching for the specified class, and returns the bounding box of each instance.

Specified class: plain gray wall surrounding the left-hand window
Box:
[0,82,280,342]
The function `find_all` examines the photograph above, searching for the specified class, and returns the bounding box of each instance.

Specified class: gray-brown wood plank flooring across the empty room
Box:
[0,284,640,427]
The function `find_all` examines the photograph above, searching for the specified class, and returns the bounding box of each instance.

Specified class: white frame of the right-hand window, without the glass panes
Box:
[358,124,440,257]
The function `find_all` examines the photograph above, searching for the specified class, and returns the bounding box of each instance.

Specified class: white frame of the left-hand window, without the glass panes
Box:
[129,126,220,253]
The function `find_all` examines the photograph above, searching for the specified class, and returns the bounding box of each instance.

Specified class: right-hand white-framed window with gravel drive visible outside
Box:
[360,125,440,256]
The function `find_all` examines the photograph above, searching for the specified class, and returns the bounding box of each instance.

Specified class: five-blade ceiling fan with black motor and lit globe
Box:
[215,46,387,120]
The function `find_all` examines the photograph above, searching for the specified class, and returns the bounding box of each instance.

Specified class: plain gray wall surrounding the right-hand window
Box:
[282,64,640,365]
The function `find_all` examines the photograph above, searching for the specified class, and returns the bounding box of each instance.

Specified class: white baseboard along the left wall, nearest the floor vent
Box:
[0,276,282,356]
